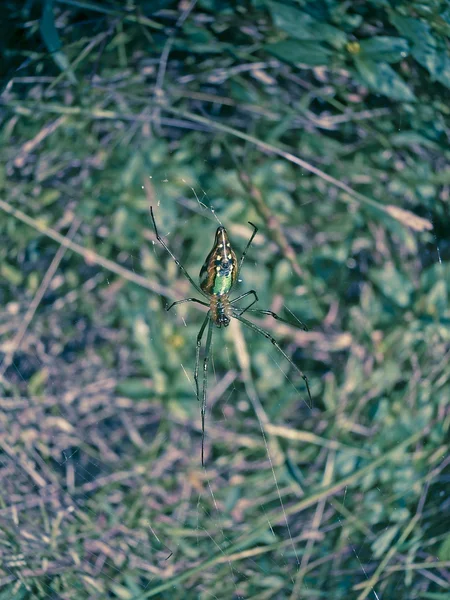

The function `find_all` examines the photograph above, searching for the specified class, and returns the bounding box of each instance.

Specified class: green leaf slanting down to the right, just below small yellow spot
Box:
[354,56,416,102]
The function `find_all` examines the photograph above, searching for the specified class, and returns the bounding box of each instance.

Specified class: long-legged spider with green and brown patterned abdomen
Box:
[150,207,312,466]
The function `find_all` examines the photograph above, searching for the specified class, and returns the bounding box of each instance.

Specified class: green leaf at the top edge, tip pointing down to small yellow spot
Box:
[268,2,347,48]
